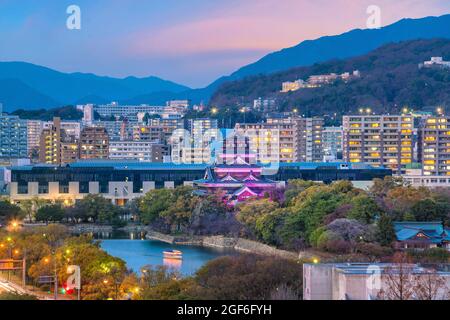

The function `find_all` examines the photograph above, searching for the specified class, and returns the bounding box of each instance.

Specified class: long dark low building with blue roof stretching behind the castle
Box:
[11,161,392,205]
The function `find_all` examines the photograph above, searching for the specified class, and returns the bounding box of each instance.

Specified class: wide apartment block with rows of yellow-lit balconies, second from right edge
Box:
[343,115,414,173]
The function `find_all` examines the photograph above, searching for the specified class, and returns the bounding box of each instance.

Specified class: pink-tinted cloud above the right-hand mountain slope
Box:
[125,0,450,56]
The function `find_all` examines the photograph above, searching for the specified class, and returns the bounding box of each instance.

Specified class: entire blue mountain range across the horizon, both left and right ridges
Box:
[0,15,450,111]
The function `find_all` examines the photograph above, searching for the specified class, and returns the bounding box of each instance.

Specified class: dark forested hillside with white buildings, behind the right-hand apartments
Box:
[211,39,450,115]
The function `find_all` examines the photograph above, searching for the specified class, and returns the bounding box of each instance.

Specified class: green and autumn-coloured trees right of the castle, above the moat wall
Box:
[237,177,450,259]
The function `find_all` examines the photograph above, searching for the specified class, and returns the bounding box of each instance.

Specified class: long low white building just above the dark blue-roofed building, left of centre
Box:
[109,141,167,162]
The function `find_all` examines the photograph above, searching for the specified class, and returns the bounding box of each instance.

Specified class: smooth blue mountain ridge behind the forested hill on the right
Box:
[231,14,450,78]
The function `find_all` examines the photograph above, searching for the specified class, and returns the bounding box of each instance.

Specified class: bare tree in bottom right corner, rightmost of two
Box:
[415,269,449,300]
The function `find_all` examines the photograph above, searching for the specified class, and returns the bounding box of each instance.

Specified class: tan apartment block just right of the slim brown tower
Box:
[80,127,109,160]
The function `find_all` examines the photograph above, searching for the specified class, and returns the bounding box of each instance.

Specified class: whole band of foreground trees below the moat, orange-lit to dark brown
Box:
[0,225,302,300]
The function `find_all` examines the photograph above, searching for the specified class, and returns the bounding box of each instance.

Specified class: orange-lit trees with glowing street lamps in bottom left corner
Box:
[0,225,139,300]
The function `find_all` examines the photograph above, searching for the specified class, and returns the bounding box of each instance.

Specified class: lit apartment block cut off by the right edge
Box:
[418,117,450,176]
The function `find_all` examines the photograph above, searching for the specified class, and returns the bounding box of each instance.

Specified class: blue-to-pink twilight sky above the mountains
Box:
[0,0,450,88]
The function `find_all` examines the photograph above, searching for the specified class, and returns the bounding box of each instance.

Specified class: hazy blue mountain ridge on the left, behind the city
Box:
[0,62,190,110]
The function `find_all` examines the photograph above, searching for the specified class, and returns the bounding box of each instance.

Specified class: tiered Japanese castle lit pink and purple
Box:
[194,154,277,205]
